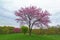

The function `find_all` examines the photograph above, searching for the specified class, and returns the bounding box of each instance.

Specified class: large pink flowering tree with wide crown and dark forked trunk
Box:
[15,6,50,35]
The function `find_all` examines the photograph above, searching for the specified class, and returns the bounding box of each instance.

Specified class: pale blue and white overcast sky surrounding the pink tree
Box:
[0,0,60,27]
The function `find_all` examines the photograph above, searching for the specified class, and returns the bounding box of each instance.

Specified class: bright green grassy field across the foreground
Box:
[0,33,60,40]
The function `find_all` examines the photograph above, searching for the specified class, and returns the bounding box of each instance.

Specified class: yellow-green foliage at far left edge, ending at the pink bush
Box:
[0,26,14,34]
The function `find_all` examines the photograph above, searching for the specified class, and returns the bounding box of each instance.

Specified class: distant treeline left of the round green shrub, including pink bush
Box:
[0,26,20,34]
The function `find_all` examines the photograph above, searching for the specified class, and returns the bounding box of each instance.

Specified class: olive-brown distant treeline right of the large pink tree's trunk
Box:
[32,27,60,34]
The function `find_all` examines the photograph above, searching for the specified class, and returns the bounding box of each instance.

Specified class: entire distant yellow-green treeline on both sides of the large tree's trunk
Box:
[0,26,60,34]
